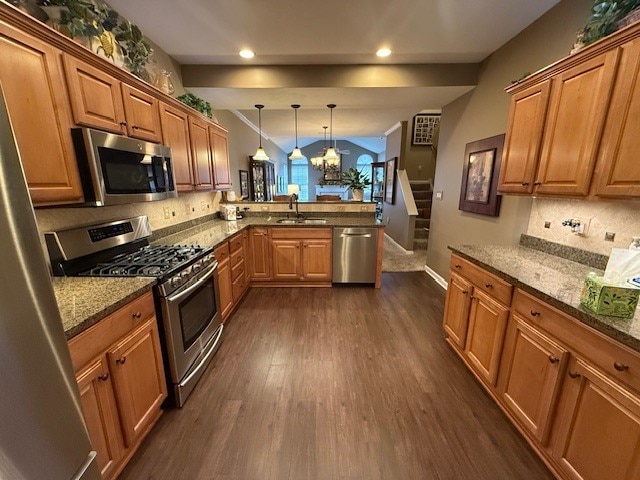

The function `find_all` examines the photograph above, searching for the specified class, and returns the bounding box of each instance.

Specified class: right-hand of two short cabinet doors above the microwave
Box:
[121,83,162,143]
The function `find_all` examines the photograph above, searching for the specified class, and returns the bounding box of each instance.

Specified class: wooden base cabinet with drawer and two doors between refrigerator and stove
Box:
[69,292,167,480]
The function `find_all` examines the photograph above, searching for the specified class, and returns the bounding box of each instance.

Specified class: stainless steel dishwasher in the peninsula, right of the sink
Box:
[333,227,378,283]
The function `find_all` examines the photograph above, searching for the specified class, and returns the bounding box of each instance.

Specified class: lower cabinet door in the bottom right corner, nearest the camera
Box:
[551,358,640,480]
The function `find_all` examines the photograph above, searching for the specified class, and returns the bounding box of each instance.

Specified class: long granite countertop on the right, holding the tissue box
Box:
[449,245,640,351]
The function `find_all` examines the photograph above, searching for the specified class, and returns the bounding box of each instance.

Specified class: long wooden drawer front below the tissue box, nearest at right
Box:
[513,289,640,392]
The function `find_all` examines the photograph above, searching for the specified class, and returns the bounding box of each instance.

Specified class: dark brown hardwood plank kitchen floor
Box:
[120,272,553,480]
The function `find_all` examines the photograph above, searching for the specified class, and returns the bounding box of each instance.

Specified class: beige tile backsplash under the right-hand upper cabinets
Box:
[527,198,640,255]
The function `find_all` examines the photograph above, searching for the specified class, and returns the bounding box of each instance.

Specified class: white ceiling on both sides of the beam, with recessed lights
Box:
[108,0,559,152]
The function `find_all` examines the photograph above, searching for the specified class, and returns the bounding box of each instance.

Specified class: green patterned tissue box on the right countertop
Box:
[580,273,640,318]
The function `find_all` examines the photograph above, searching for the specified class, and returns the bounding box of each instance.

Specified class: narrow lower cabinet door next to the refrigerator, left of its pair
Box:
[76,358,124,478]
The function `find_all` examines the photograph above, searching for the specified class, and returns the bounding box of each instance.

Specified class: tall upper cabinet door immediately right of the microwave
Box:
[160,103,194,192]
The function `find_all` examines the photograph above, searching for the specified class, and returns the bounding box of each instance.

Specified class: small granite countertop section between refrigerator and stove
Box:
[51,277,155,340]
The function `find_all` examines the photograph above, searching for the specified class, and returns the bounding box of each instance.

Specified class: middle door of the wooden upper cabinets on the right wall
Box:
[534,49,619,195]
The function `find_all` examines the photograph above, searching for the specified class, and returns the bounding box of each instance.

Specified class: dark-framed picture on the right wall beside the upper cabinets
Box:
[458,134,504,217]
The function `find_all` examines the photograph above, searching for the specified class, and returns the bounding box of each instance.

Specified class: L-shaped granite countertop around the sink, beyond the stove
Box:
[153,214,385,247]
